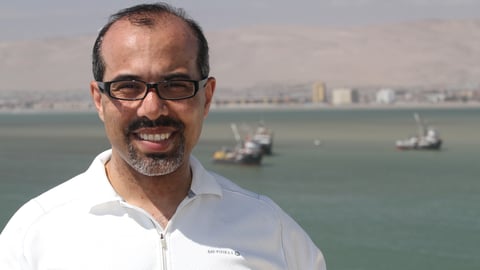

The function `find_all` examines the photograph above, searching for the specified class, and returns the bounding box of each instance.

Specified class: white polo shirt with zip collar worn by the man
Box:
[0,150,326,270]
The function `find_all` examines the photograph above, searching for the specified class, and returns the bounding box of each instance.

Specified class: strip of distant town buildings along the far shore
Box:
[0,81,480,112]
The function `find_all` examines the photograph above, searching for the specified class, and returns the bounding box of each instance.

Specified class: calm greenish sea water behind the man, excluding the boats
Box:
[0,109,480,270]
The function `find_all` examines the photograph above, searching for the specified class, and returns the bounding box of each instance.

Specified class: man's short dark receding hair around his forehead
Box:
[92,2,210,81]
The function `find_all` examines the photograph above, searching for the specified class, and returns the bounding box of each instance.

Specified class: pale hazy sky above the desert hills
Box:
[0,0,480,40]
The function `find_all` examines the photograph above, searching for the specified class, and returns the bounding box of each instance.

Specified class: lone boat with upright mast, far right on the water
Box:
[395,113,442,150]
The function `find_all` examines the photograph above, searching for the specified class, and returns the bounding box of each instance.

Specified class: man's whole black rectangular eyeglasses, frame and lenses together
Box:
[97,78,208,100]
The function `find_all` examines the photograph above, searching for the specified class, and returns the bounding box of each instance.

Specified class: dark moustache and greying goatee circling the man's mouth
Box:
[126,115,185,176]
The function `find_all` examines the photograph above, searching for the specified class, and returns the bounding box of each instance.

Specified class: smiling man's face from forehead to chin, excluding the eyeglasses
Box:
[91,18,215,176]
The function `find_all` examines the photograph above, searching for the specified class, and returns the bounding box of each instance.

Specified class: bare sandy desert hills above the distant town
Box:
[0,20,480,96]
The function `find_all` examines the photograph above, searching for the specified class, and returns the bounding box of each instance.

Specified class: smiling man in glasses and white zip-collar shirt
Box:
[0,3,325,270]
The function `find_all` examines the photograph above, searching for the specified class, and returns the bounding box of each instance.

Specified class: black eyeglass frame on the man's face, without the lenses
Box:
[97,77,210,101]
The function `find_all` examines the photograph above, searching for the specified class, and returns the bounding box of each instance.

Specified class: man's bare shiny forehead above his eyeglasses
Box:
[101,14,199,76]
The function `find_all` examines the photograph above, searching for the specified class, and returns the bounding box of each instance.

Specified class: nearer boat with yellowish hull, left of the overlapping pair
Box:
[212,124,263,165]
